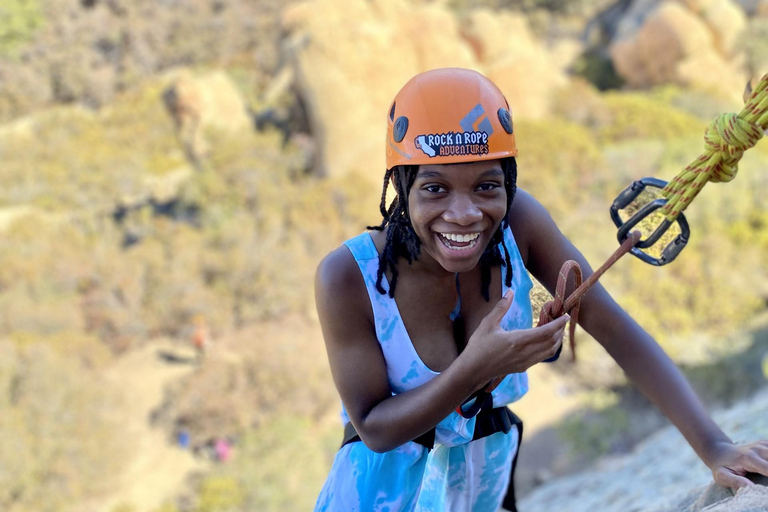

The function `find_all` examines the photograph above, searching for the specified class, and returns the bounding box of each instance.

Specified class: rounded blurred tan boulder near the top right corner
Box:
[610,0,746,98]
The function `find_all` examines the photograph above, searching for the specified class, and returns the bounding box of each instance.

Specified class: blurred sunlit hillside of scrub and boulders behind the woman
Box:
[0,0,768,512]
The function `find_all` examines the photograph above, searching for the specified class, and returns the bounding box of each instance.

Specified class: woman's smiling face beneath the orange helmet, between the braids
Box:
[408,160,507,273]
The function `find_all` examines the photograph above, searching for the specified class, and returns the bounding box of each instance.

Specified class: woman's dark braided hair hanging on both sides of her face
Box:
[368,157,517,302]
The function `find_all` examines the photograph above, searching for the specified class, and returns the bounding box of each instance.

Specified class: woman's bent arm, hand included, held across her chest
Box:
[315,247,565,452]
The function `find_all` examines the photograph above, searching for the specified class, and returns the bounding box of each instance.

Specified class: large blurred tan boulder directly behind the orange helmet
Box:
[283,0,567,183]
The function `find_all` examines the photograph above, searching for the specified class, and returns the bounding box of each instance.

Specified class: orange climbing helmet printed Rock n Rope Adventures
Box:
[387,68,517,169]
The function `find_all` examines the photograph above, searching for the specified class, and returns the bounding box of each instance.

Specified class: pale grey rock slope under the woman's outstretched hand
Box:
[519,391,768,512]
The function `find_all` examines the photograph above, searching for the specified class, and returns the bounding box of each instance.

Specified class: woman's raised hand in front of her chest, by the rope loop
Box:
[464,290,570,381]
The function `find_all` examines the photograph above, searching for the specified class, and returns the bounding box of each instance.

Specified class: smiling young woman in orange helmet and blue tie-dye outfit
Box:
[315,68,768,512]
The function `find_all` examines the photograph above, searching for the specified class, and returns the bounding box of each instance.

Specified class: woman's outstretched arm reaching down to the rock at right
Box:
[510,192,768,487]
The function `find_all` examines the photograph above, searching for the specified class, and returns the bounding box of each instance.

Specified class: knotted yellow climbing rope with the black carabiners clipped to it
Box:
[611,74,768,266]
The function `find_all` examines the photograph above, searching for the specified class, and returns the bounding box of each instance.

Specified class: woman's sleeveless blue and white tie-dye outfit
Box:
[315,228,532,512]
